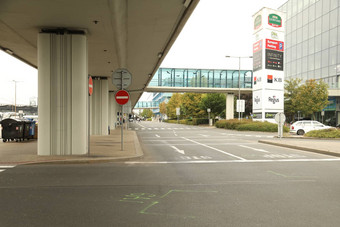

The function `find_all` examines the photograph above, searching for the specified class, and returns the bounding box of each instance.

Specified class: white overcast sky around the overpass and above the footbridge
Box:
[0,0,287,105]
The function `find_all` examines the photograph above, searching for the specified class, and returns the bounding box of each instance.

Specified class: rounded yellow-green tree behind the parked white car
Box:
[292,80,328,119]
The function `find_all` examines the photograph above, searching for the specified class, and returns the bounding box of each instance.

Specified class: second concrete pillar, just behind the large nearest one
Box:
[90,78,109,135]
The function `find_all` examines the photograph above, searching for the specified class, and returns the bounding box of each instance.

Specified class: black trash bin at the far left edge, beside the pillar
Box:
[0,118,25,142]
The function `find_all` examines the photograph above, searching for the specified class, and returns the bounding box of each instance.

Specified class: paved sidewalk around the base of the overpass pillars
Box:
[0,129,143,165]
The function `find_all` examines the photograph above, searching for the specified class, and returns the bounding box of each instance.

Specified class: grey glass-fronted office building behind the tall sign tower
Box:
[278,0,340,125]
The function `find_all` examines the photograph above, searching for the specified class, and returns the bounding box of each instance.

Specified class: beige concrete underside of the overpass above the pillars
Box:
[0,0,199,105]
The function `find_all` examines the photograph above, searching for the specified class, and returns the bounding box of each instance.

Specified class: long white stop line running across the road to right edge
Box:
[124,158,340,165]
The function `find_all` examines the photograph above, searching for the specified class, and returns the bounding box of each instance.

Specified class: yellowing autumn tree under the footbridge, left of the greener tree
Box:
[181,93,205,118]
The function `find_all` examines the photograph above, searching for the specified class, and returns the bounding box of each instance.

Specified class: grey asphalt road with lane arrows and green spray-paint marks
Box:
[0,119,340,226]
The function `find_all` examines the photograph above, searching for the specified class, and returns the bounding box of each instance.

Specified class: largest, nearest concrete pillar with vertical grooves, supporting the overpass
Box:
[38,33,88,155]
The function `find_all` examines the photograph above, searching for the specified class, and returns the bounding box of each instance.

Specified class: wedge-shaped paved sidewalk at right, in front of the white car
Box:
[259,137,340,157]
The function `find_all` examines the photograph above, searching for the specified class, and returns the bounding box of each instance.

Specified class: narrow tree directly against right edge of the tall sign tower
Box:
[284,78,301,121]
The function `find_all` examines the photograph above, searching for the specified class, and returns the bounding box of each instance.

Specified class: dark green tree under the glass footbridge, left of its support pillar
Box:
[201,93,226,118]
